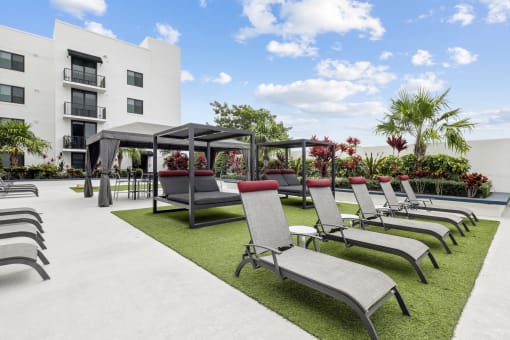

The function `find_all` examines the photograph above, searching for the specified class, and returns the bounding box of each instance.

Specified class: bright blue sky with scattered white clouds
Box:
[0,0,510,146]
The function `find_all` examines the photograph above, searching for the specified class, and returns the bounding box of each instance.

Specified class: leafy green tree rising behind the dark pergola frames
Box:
[211,101,291,165]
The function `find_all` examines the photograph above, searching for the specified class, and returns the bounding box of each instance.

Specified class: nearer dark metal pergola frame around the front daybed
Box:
[152,123,255,228]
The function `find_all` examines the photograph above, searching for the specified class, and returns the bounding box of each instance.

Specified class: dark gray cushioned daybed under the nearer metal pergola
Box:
[156,170,244,228]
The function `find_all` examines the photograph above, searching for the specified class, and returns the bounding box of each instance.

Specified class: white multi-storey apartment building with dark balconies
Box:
[0,20,181,168]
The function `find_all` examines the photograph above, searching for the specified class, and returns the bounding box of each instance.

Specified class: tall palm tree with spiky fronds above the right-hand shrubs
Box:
[376,89,475,170]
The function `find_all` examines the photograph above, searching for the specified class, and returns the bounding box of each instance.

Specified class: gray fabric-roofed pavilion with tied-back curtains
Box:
[84,122,250,207]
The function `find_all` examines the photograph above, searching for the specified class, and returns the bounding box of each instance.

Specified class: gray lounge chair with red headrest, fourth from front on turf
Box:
[378,176,469,236]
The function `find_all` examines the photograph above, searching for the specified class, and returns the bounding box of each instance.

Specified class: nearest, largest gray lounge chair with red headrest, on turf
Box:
[235,180,410,339]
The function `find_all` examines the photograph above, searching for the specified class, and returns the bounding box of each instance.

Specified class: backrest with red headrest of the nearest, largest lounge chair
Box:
[237,180,292,254]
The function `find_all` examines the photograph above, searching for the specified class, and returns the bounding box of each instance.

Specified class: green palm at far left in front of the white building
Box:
[0,120,50,166]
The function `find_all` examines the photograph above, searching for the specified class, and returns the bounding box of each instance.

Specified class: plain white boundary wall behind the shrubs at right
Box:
[358,138,510,192]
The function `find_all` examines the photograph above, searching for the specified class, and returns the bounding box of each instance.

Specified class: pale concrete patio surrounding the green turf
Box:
[0,181,510,339]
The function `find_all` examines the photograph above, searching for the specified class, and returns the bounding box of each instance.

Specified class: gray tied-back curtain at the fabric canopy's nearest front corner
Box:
[98,139,120,207]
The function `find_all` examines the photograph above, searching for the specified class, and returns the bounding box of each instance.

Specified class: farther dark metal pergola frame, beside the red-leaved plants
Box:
[256,139,335,208]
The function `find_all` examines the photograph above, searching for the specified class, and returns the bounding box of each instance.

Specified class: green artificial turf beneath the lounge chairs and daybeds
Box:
[113,199,499,339]
